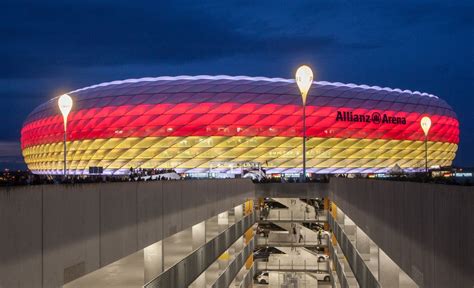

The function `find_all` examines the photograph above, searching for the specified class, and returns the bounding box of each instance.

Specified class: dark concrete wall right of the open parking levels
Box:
[329,178,474,288]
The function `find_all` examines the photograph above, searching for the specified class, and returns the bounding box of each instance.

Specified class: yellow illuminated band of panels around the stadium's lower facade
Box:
[23,136,458,172]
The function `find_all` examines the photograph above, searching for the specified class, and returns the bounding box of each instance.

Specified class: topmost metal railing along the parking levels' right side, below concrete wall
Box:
[328,213,380,288]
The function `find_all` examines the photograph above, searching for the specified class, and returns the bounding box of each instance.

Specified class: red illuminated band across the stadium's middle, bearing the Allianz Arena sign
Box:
[22,103,459,148]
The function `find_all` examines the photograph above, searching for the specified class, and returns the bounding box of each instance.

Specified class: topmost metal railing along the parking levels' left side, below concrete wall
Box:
[144,213,256,288]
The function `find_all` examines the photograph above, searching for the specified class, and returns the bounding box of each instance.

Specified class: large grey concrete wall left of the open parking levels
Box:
[0,179,254,288]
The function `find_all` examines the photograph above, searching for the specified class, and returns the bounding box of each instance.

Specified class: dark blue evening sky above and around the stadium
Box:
[0,0,474,168]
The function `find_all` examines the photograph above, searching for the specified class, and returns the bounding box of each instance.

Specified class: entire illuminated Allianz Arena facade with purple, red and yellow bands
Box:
[21,76,459,174]
